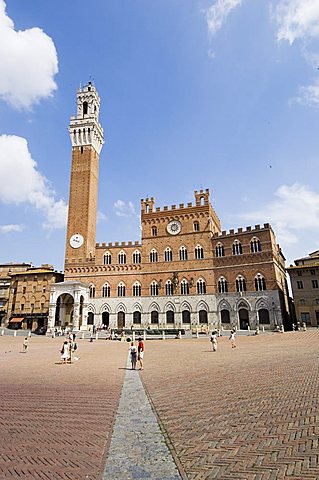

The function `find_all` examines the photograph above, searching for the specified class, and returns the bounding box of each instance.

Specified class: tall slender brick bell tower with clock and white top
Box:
[65,82,104,267]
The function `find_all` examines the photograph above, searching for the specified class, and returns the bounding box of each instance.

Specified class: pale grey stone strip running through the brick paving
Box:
[102,358,182,480]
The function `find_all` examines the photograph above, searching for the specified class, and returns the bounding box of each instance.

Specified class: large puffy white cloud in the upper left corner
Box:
[0,0,58,108]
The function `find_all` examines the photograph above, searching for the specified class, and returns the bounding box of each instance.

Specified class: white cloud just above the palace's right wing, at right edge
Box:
[240,183,319,246]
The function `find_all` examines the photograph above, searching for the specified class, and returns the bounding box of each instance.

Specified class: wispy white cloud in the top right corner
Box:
[273,0,319,45]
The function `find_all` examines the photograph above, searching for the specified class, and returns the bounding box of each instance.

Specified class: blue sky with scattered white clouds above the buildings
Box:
[0,0,319,270]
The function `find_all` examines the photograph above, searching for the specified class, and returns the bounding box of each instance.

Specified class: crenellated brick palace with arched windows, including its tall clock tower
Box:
[48,82,288,330]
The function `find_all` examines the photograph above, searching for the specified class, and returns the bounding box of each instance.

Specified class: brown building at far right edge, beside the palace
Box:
[287,250,319,327]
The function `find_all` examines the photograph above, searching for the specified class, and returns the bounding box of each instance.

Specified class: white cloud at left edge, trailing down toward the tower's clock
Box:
[0,135,67,229]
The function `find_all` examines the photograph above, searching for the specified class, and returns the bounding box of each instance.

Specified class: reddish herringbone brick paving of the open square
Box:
[0,331,319,480]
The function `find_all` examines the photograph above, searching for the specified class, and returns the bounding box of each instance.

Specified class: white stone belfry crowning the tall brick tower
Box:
[69,82,104,155]
